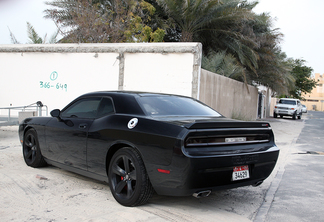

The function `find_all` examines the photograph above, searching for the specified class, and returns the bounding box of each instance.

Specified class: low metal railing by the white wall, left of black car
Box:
[0,101,48,126]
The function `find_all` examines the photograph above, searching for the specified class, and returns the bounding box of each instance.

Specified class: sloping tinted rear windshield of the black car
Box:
[139,96,221,117]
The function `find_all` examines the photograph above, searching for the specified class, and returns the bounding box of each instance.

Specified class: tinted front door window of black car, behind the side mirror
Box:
[61,98,101,118]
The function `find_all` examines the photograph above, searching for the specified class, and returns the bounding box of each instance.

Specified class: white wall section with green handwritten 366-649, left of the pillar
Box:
[0,52,119,112]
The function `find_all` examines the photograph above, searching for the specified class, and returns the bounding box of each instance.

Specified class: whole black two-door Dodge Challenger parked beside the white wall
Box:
[19,91,279,206]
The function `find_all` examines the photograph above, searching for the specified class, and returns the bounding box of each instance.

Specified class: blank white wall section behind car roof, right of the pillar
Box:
[124,53,194,96]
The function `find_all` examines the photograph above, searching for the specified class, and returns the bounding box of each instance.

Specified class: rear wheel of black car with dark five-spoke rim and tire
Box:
[108,147,154,207]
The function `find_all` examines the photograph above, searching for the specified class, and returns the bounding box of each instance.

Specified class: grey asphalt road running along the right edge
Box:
[254,111,324,222]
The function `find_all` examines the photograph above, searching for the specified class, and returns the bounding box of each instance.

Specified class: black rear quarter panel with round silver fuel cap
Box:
[87,115,186,177]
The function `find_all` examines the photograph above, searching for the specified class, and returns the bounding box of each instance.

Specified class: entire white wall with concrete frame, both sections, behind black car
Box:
[0,43,201,115]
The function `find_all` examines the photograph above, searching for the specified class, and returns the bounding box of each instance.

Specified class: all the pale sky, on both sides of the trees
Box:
[0,0,324,74]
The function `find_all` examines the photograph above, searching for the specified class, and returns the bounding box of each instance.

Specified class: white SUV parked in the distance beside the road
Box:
[273,98,303,119]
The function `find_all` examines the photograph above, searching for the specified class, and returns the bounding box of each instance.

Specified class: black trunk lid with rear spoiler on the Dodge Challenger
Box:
[153,116,270,129]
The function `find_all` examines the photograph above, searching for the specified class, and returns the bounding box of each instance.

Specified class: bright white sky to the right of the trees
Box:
[254,0,324,74]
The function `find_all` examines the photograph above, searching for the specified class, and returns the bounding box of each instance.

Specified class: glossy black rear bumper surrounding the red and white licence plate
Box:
[149,146,279,196]
